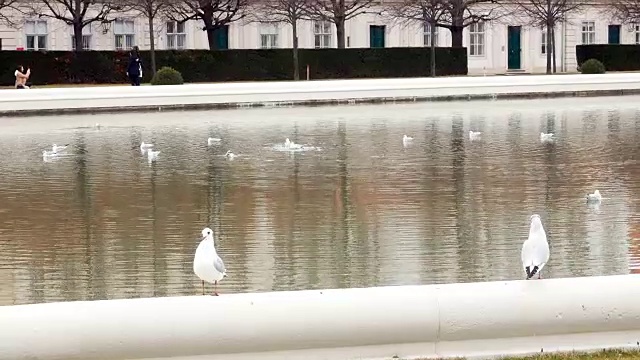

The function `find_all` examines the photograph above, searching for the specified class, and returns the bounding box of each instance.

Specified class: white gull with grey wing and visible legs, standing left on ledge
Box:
[193,228,227,296]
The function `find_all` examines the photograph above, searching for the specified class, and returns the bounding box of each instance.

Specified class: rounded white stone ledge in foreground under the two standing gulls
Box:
[0,275,640,360]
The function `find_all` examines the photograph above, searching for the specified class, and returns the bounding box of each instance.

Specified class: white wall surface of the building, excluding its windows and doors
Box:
[0,3,636,74]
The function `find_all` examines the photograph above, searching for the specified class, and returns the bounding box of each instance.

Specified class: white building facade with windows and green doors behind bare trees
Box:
[0,7,640,74]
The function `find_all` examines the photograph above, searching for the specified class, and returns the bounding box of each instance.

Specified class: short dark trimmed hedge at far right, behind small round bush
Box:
[576,44,640,71]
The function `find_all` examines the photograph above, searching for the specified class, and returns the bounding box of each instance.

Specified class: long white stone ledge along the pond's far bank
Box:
[0,73,640,115]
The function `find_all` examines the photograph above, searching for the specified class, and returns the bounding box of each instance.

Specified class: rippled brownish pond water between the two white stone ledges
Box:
[0,97,640,305]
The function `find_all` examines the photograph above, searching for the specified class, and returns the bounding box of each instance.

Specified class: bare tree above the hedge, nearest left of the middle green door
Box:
[307,0,378,49]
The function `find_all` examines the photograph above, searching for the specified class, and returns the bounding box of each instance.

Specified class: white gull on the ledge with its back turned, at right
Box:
[521,214,549,280]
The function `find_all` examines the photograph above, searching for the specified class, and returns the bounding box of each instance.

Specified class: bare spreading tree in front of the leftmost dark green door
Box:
[165,0,252,50]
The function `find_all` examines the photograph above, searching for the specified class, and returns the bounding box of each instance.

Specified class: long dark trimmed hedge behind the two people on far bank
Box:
[0,47,467,85]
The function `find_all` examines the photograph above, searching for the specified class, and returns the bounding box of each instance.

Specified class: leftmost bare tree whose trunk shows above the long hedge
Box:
[29,0,119,51]
